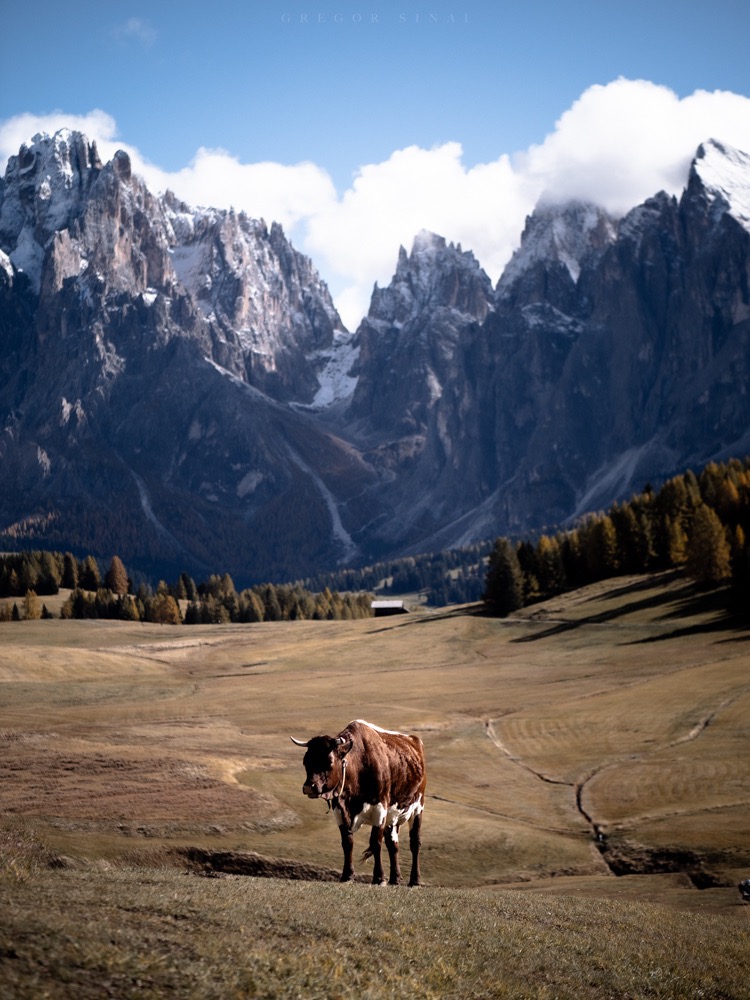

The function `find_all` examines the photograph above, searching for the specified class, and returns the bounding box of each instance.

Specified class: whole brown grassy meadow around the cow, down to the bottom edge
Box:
[0,575,750,1000]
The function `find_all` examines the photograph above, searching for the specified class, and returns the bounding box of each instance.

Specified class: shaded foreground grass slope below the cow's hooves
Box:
[0,868,750,1000]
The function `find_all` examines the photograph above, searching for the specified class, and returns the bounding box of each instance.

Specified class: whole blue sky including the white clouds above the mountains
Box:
[0,0,750,325]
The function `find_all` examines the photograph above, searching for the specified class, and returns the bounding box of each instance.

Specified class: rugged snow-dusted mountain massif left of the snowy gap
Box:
[0,133,374,579]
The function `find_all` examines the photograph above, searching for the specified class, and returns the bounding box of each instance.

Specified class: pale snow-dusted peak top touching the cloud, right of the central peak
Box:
[498,201,617,296]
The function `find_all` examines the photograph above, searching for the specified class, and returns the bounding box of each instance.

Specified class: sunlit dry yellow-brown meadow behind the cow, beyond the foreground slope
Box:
[0,579,750,915]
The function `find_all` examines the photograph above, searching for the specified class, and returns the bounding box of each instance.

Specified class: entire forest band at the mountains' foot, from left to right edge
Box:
[0,459,750,625]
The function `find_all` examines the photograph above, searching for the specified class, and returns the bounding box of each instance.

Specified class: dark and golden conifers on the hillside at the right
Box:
[484,459,750,616]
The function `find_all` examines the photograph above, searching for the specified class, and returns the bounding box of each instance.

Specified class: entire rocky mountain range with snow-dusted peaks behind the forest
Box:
[0,131,750,583]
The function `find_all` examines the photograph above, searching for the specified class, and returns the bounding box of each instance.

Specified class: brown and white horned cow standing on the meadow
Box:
[291,719,427,886]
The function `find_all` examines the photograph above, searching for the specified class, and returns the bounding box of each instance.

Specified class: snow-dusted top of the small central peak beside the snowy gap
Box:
[365,230,492,324]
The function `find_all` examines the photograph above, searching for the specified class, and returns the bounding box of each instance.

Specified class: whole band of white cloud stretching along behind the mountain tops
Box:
[0,79,750,328]
